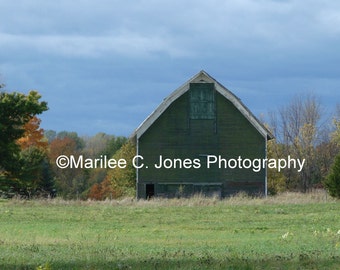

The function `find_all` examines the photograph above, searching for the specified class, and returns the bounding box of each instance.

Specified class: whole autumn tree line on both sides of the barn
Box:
[0,86,340,200]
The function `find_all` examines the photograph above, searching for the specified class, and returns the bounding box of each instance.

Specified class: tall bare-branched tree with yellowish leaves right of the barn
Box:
[271,94,322,192]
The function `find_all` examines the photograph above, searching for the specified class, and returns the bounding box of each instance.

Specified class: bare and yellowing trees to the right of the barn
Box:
[267,93,340,197]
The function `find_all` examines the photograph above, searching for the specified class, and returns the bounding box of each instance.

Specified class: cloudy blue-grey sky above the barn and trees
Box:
[0,0,340,136]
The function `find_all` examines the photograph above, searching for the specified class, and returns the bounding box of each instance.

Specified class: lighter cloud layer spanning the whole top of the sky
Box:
[0,0,340,58]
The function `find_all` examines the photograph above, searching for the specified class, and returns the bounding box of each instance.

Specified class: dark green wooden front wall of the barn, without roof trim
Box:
[138,84,266,198]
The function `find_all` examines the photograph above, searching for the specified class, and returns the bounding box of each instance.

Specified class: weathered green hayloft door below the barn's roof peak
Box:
[190,83,215,119]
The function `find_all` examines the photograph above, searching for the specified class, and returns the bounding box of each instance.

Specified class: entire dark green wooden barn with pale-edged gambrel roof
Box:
[132,71,273,199]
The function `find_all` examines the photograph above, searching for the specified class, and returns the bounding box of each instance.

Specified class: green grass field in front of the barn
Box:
[0,193,340,269]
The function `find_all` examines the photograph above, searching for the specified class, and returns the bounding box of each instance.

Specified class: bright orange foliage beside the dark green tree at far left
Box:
[17,116,48,150]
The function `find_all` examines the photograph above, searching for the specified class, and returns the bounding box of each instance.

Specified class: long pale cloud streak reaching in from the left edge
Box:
[0,32,190,57]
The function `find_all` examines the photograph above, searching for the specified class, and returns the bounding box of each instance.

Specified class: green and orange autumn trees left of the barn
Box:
[0,87,134,199]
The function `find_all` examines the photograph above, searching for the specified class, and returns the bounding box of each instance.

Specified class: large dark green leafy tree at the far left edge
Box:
[0,91,48,175]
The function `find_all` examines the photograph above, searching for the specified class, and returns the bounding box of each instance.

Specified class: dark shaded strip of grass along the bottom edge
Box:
[0,256,340,270]
